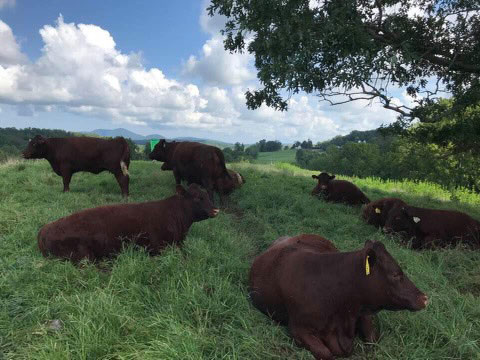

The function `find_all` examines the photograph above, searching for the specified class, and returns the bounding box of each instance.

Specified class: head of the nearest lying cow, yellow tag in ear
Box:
[359,241,428,311]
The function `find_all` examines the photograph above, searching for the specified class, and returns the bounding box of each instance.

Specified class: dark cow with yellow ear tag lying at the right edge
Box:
[384,205,480,249]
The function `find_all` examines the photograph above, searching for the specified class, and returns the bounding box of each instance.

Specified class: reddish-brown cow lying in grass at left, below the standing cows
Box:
[38,184,219,263]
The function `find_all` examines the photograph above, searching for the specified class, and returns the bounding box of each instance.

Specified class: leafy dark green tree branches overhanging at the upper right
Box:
[208,0,480,148]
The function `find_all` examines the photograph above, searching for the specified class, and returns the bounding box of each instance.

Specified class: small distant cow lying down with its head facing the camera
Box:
[312,172,370,205]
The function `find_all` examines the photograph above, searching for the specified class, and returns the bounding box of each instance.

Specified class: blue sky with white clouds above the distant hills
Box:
[0,0,409,143]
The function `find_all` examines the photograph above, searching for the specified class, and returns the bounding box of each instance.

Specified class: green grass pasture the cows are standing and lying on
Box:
[0,160,480,360]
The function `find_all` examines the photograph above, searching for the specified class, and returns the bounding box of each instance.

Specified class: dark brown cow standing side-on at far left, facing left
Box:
[23,135,130,197]
